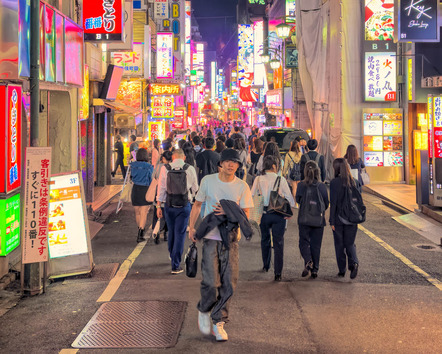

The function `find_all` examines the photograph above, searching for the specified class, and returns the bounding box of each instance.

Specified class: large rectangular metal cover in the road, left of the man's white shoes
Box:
[72,301,187,348]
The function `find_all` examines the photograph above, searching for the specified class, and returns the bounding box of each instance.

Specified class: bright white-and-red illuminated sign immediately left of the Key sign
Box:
[365,0,396,41]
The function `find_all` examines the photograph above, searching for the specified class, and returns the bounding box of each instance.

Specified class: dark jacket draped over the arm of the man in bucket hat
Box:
[195,199,253,249]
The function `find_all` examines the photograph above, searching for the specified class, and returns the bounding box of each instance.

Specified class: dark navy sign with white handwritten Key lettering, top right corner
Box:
[397,0,439,42]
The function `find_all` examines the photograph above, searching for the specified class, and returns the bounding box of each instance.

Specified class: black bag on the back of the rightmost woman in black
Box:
[338,185,367,225]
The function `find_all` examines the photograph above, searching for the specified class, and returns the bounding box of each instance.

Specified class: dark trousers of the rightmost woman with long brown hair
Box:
[333,225,359,273]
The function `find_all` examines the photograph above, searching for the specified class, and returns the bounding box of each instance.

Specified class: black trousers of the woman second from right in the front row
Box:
[298,225,324,272]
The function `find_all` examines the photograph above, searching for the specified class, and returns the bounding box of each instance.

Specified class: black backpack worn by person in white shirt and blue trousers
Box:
[165,163,190,208]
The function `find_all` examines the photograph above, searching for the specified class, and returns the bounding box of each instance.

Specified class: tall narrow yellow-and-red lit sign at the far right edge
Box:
[428,95,442,207]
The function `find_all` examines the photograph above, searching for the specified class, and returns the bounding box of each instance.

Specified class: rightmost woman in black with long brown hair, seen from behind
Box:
[330,158,359,279]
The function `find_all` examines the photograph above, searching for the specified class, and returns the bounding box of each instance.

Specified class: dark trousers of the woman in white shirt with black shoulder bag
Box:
[259,213,286,275]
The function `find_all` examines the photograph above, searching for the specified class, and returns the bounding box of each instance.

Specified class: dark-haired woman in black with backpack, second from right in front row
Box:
[296,161,329,279]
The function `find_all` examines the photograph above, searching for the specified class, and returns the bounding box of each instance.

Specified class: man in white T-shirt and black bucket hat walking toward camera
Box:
[189,149,253,341]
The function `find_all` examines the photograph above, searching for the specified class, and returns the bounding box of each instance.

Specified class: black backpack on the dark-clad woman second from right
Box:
[298,183,325,227]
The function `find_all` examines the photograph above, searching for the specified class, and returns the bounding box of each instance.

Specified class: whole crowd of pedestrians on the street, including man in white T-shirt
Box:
[116,123,365,341]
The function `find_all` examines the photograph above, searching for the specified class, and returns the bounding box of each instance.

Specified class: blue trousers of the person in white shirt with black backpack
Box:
[164,203,191,270]
